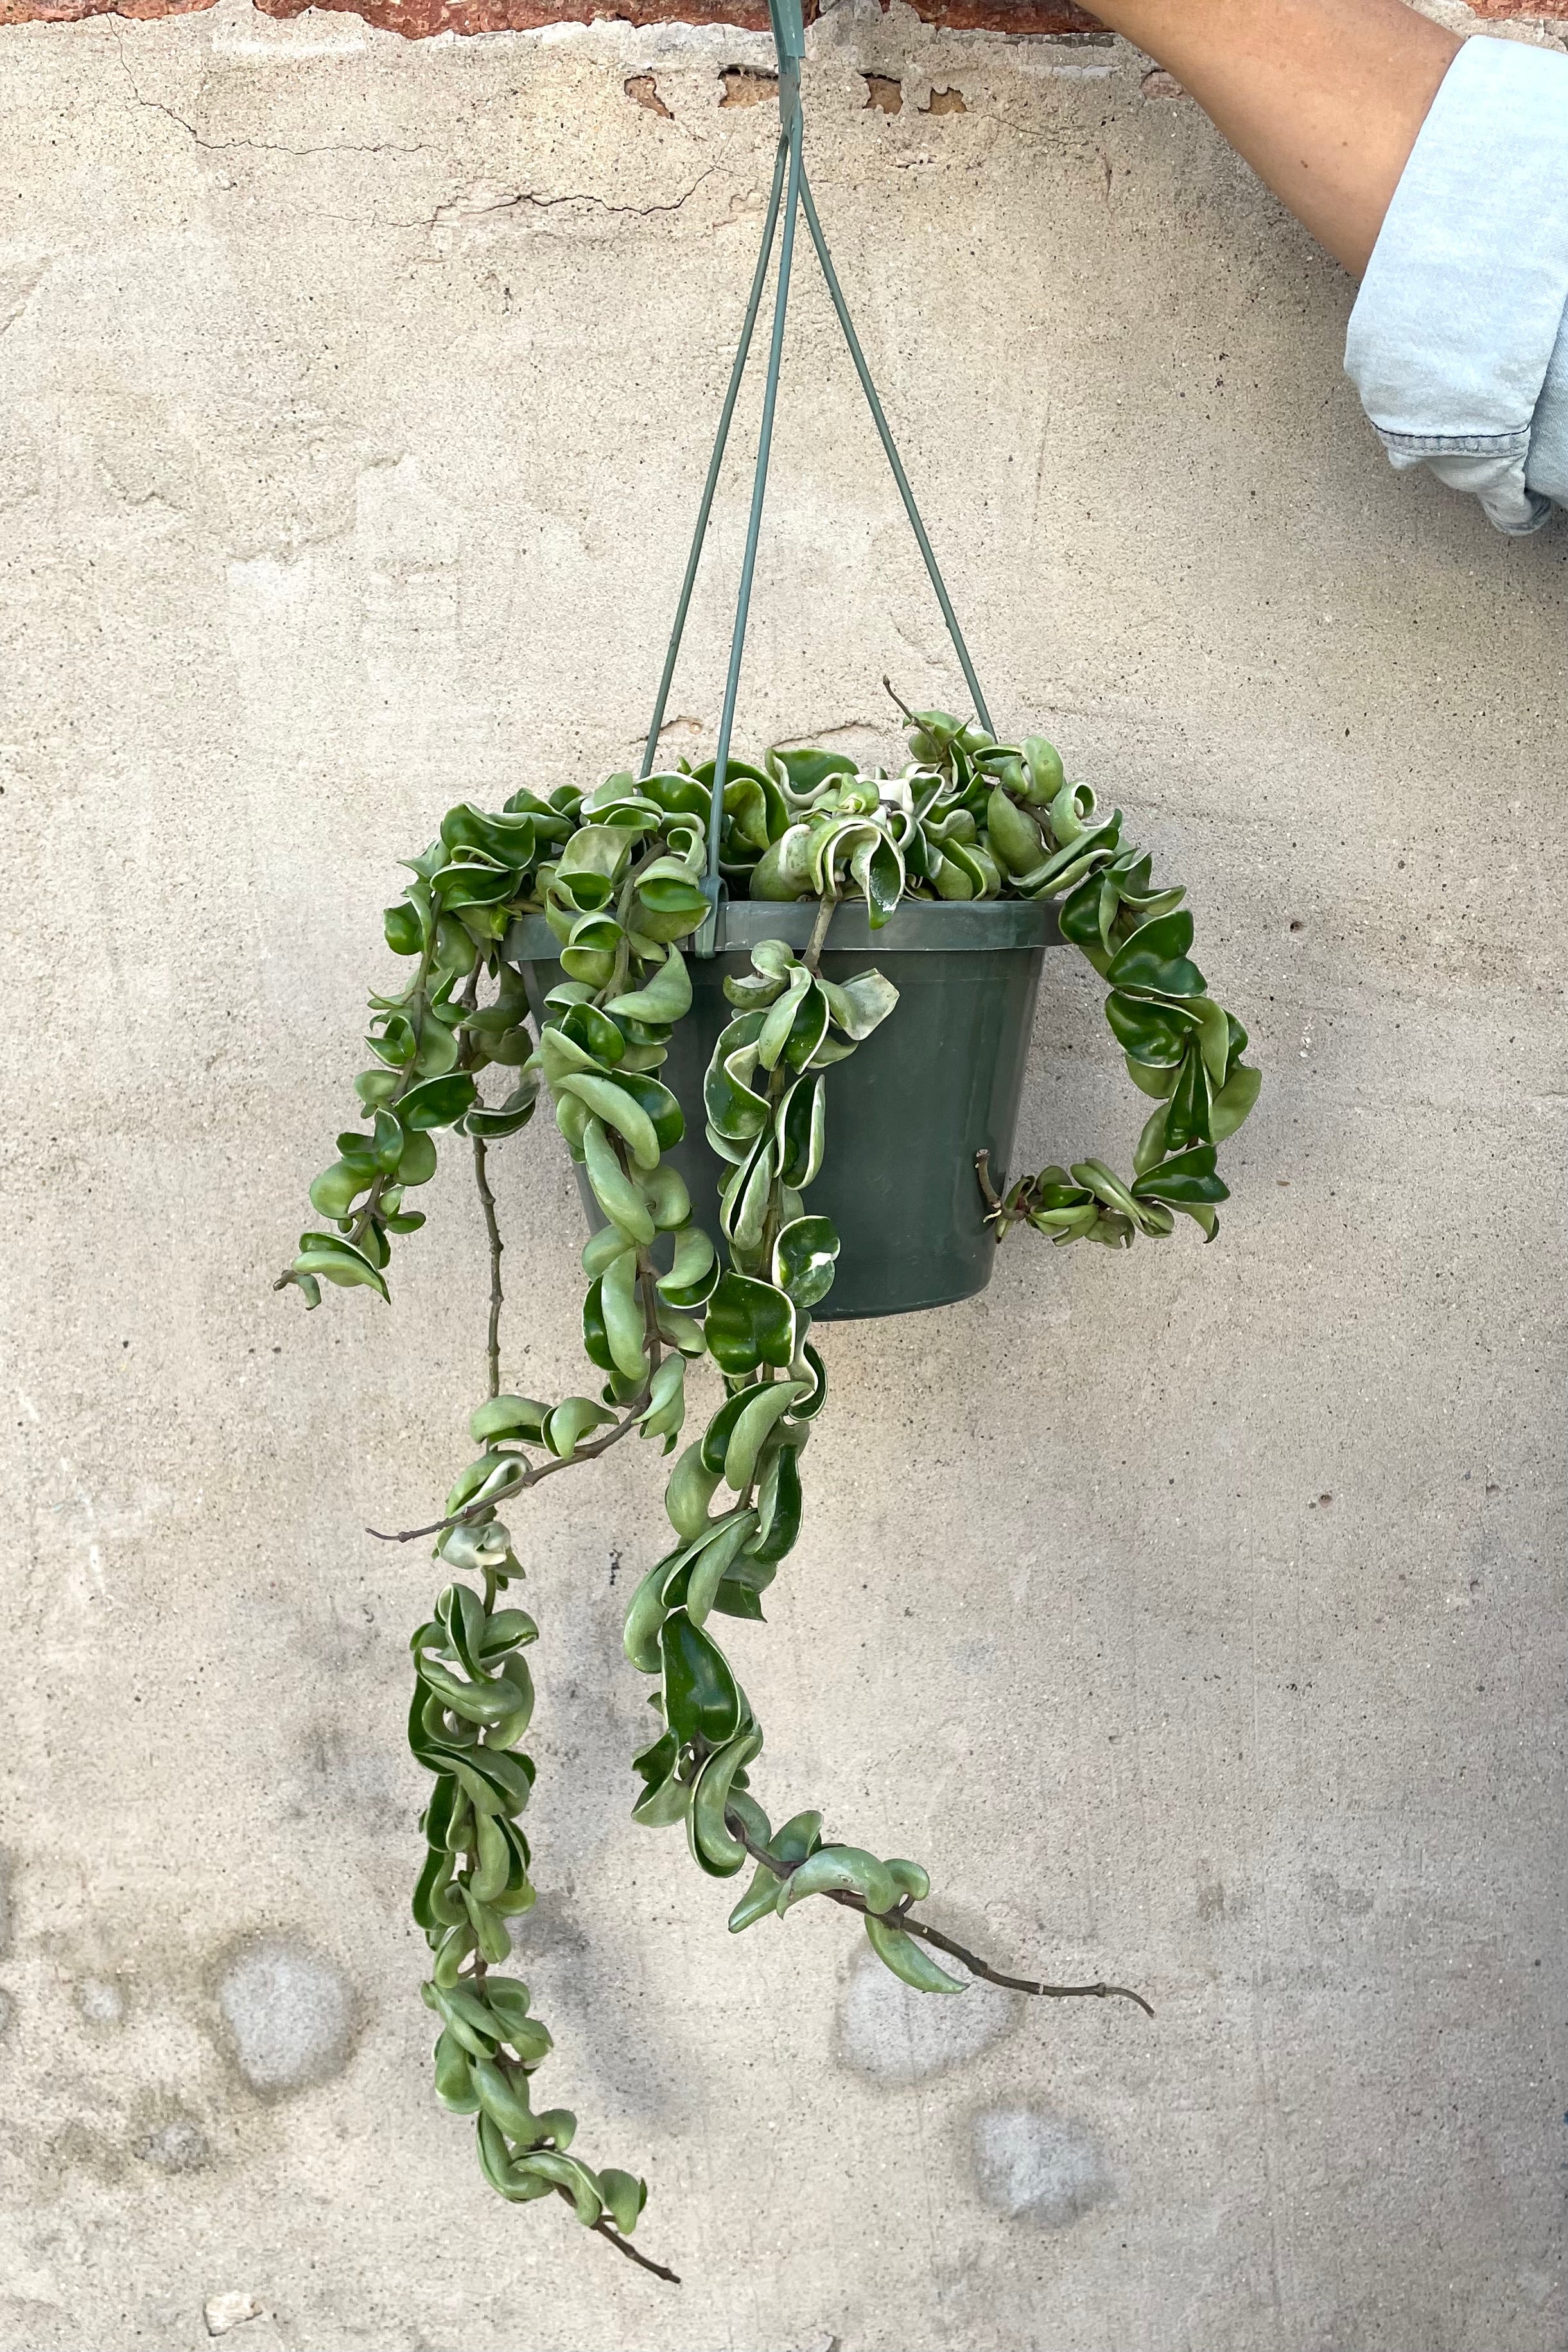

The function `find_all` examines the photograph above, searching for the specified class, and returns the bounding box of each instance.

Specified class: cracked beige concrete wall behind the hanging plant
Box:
[0,0,1568,2352]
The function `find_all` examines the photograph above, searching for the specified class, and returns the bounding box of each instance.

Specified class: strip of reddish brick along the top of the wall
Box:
[0,0,1568,40]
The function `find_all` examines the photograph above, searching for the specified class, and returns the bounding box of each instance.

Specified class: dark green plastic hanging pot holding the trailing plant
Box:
[503,898,1063,1322]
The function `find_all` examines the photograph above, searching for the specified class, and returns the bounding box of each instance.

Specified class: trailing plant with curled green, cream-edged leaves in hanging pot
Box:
[280,713,1258,2277]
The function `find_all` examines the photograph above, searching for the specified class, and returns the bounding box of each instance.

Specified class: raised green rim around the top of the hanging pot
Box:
[501,898,1067,964]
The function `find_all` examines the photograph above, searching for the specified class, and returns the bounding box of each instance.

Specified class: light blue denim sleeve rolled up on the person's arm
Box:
[1345,38,1568,534]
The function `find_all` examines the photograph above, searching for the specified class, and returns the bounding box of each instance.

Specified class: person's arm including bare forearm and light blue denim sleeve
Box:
[1093,0,1568,534]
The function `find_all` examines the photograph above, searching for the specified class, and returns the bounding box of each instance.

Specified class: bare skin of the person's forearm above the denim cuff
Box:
[1093,0,1462,277]
